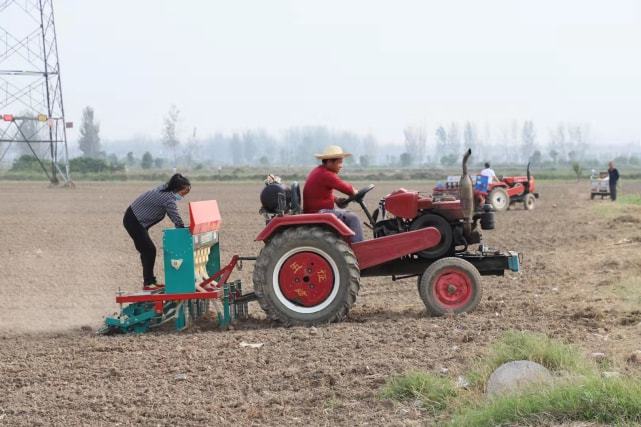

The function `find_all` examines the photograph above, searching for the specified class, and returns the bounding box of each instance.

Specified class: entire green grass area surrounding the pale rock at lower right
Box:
[381,331,641,426]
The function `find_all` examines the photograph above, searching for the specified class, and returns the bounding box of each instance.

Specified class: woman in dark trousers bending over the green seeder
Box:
[122,173,191,291]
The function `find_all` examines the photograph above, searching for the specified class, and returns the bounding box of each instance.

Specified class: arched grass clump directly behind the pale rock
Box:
[468,331,595,387]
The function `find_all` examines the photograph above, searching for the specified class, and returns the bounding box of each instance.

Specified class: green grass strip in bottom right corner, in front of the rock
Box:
[449,376,641,426]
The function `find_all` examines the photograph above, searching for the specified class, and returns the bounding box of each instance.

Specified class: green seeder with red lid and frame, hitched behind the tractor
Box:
[100,200,255,333]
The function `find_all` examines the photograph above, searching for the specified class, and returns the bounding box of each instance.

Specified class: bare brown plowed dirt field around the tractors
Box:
[0,182,641,425]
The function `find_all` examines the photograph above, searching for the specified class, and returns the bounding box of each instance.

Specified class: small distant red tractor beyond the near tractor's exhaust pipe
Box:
[476,163,539,211]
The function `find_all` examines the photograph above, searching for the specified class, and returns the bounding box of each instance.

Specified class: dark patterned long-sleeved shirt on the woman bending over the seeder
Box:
[131,184,185,228]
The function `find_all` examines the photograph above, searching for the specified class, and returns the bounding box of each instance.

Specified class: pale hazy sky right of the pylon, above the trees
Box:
[54,0,641,142]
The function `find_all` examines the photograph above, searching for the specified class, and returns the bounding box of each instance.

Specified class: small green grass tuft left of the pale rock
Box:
[381,372,457,415]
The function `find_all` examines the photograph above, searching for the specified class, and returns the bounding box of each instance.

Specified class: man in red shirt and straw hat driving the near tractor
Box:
[303,145,363,243]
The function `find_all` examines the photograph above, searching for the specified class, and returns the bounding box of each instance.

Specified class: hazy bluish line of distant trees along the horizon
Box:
[6,105,641,171]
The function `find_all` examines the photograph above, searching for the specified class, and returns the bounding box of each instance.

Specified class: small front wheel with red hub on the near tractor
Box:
[418,257,482,316]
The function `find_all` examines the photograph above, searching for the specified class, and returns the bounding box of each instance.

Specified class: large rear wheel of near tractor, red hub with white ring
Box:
[253,226,360,326]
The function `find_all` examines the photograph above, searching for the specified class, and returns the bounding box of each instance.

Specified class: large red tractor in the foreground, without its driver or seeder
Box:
[251,150,520,325]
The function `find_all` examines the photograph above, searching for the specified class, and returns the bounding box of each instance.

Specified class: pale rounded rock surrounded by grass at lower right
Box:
[485,360,552,395]
